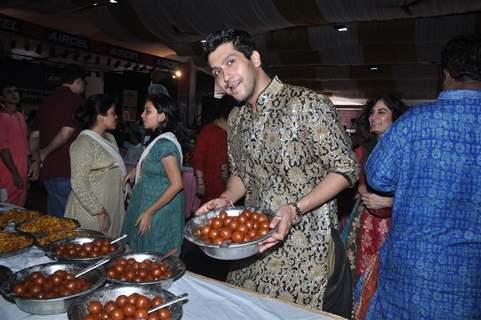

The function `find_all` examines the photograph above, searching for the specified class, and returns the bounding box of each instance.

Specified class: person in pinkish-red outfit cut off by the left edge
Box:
[0,83,28,207]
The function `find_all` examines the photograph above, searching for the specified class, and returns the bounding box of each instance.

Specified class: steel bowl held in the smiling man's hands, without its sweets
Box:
[184,207,274,260]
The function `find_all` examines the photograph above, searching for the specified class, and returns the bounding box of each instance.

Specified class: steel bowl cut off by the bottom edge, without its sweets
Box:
[67,285,182,320]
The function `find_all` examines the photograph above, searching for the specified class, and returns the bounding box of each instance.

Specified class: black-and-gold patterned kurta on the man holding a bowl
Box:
[228,78,359,309]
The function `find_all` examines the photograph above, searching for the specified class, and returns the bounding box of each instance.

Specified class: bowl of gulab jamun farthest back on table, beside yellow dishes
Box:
[45,235,125,263]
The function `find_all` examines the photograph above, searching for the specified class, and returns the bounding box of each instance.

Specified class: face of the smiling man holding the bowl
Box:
[208,42,256,102]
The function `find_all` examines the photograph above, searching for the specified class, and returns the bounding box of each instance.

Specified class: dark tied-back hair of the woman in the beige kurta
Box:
[73,94,114,129]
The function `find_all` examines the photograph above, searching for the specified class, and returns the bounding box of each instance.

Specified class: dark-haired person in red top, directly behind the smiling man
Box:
[192,96,234,202]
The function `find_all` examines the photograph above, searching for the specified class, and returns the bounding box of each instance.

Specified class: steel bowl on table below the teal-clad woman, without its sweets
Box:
[106,252,185,289]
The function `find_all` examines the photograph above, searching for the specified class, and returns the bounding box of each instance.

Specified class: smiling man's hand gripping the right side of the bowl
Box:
[259,204,296,252]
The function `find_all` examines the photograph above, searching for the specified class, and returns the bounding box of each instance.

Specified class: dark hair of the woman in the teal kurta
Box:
[147,94,177,145]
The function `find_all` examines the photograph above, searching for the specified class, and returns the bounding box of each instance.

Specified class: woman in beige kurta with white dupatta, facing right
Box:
[65,94,126,237]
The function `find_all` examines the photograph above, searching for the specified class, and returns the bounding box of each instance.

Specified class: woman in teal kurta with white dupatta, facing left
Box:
[123,95,184,254]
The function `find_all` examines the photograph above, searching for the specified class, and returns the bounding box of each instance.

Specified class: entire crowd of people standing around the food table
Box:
[0,29,481,319]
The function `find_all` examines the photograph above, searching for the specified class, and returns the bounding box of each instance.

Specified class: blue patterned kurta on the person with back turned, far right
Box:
[366,90,481,319]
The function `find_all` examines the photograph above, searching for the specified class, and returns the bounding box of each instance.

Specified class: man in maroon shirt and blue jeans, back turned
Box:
[30,65,85,217]
